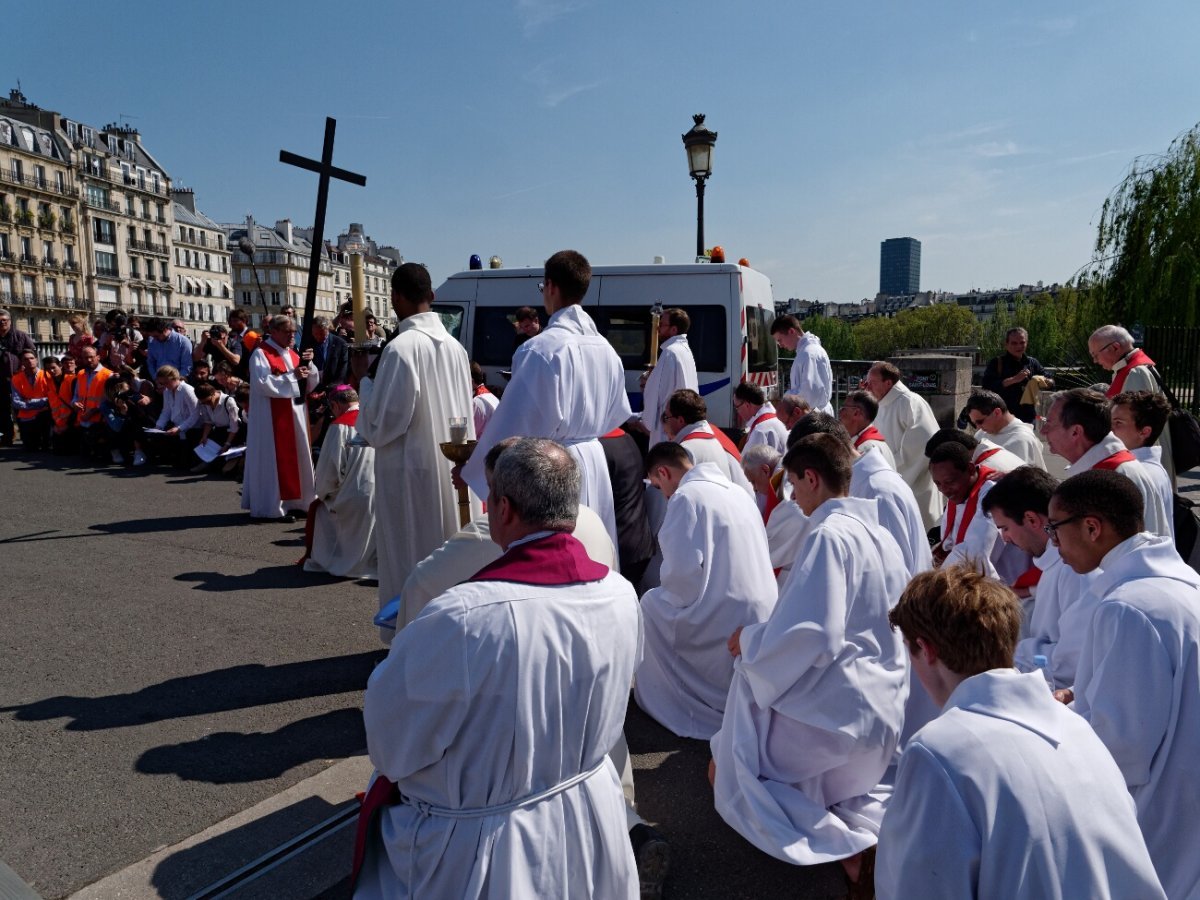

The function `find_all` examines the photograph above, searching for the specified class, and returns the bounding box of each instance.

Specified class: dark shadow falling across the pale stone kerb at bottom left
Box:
[150,797,358,900]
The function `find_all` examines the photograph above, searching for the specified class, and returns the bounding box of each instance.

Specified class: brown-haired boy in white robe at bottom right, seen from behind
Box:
[875,566,1165,900]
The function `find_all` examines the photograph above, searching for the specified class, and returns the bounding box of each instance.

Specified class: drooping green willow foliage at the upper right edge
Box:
[1090,125,1200,326]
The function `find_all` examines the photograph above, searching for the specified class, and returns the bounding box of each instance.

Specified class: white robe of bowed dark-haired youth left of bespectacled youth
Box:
[1014,542,1099,690]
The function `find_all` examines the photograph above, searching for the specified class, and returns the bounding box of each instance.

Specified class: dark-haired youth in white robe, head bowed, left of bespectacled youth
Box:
[983,466,1099,688]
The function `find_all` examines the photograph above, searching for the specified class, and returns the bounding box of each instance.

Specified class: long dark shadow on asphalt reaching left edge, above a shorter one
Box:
[0,648,388,731]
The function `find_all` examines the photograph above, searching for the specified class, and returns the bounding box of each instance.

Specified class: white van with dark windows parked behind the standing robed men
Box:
[433,263,779,428]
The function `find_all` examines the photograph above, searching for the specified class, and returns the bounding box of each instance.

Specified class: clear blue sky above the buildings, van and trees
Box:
[9,0,1200,301]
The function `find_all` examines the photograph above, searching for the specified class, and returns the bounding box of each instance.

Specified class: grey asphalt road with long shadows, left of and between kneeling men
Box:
[0,450,845,900]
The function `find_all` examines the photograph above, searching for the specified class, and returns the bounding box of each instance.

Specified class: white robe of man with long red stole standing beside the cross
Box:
[241,338,320,518]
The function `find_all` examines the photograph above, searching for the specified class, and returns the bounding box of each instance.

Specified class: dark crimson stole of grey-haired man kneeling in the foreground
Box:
[350,532,608,887]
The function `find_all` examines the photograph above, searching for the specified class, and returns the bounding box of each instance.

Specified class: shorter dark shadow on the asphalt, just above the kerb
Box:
[134,706,367,785]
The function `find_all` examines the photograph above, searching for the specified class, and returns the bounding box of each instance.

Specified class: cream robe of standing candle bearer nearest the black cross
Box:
[358,312,481,608]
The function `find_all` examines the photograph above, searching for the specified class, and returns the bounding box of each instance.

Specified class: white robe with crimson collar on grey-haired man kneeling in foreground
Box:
[355,533,642,900]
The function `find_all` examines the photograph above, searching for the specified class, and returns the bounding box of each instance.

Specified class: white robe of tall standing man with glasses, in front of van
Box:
[462,305,632,554]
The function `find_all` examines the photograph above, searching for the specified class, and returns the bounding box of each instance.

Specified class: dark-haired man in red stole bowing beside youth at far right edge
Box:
[1042,388,1171,538]
